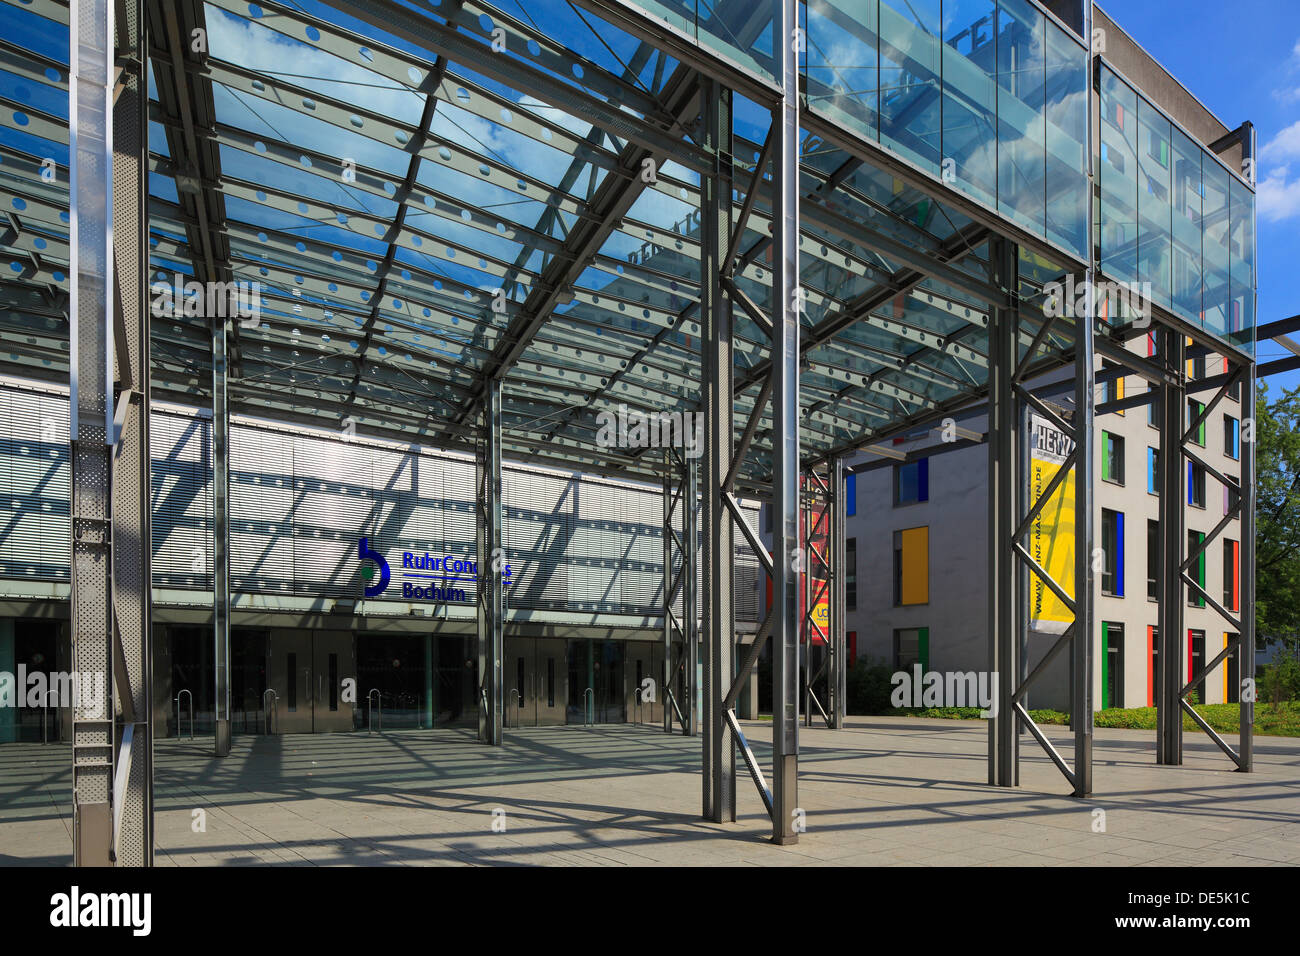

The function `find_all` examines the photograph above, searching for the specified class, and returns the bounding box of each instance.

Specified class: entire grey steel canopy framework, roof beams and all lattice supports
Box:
[0,0,1253,864]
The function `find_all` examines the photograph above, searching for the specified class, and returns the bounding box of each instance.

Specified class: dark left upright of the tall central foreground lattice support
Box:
[699,74,736,823]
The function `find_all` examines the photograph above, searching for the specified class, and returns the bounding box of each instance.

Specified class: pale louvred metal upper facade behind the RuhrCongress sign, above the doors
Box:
[0,384,762,620]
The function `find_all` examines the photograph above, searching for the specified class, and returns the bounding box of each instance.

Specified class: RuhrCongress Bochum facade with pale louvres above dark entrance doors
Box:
[0,380,762,743]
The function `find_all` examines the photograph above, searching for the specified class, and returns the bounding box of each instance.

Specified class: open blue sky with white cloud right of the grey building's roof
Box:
[1101,0,1300,397]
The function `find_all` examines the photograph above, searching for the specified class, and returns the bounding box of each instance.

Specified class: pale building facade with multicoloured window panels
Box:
[845,338,1260,710]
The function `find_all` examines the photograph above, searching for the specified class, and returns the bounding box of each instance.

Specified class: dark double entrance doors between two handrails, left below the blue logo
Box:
[267,631,356,734]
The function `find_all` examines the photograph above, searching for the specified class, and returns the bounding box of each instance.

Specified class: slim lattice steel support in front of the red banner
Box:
[802,458,846,730]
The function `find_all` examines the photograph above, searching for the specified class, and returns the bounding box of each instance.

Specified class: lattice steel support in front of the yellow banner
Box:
[988,238,1095,796]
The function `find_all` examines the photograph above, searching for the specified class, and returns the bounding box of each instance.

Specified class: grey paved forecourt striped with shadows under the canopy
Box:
[0,718,1300,866]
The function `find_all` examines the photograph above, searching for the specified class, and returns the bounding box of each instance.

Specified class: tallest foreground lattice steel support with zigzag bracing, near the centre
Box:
[699,3,805,844]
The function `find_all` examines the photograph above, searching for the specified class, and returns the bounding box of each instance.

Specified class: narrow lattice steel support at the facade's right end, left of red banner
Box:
[663,447,699,736]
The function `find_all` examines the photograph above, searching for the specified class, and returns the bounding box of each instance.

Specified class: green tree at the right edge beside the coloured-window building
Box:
[1242,382,1300,652]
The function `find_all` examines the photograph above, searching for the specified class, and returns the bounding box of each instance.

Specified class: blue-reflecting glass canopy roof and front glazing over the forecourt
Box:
[0,0,1253,486]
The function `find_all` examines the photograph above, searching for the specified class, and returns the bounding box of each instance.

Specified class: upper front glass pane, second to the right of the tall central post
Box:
[880,0,943,176]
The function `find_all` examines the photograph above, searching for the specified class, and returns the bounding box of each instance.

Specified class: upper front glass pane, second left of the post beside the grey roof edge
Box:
[997,0,1047,235]
